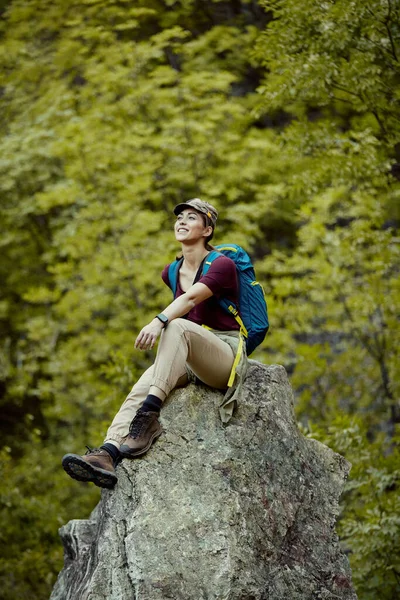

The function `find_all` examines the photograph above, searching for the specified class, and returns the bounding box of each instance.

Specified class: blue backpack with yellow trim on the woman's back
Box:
[168,244,269,356]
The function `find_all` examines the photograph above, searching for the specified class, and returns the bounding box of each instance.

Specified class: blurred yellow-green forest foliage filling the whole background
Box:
[0,0,400,600]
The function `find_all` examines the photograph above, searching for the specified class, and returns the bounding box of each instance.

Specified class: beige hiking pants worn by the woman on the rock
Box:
[104,319,235,444]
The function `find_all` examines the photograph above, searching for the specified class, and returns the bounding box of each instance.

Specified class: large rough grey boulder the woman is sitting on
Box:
[51,361,356,600]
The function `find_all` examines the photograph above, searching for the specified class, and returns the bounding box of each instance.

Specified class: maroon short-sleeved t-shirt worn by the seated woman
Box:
[161,254,239,331]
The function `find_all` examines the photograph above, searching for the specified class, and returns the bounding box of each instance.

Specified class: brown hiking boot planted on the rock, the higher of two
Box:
[119,410,162,458]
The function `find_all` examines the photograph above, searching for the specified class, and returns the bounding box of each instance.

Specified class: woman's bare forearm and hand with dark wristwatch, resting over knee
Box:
[135,283,213,350]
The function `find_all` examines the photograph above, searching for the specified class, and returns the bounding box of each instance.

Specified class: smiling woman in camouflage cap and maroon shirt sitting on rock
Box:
[62,198,247,488]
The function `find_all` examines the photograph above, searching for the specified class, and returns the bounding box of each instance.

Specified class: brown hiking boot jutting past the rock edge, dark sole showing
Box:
[62,446,118,489]
